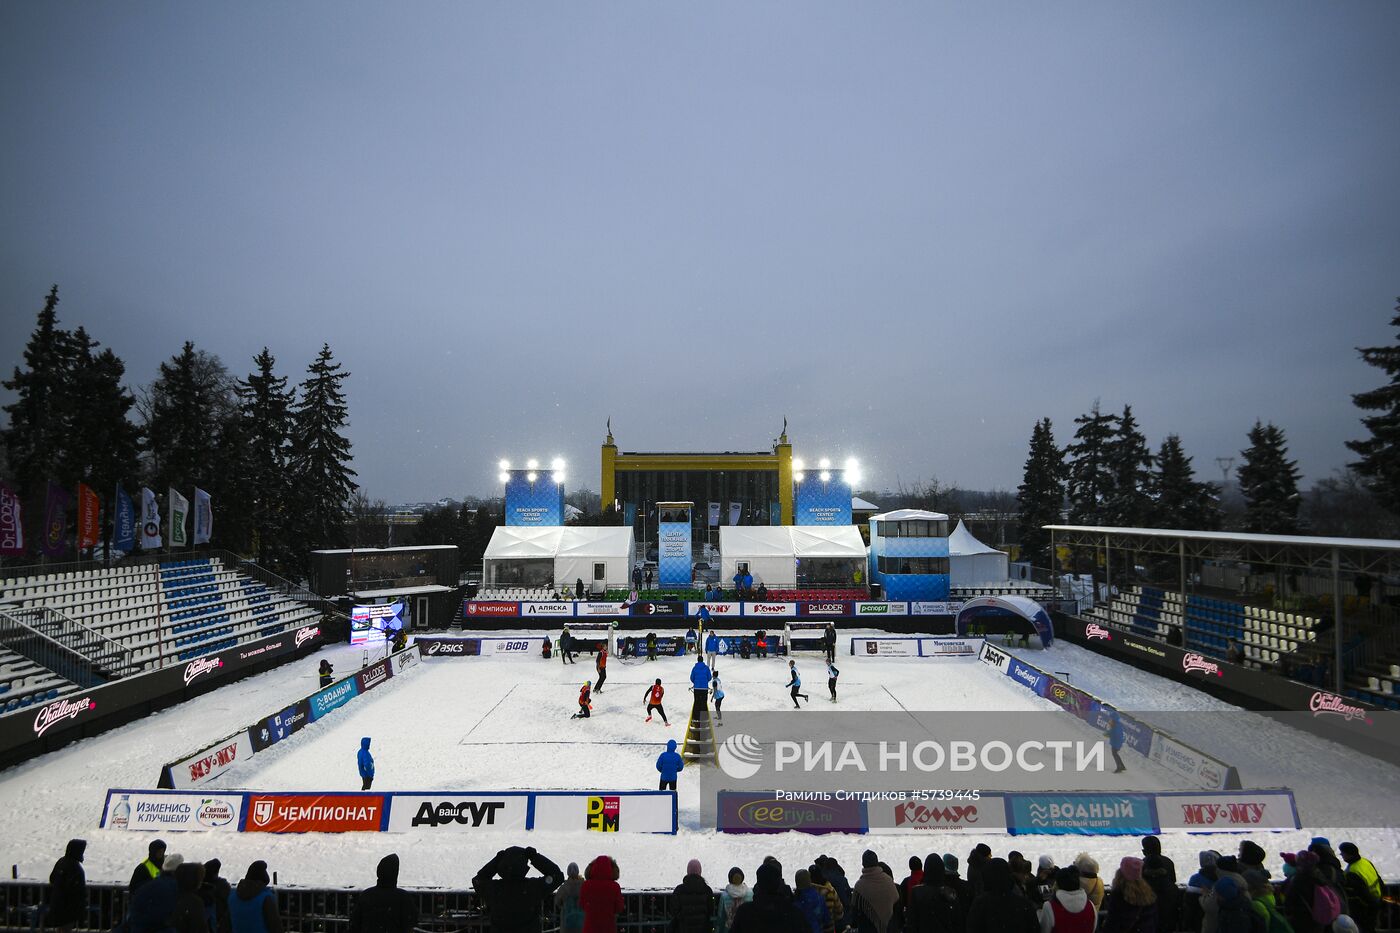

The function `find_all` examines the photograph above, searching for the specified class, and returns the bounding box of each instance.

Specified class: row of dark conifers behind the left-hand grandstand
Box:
[0,286,357,577]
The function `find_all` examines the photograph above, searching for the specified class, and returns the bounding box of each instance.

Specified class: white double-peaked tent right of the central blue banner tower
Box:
[720,525,865,590]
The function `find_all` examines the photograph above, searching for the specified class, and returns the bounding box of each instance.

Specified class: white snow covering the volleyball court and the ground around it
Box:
[0,632,1400,888]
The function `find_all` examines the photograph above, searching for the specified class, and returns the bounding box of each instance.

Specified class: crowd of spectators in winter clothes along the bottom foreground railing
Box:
[42,836,1385,933]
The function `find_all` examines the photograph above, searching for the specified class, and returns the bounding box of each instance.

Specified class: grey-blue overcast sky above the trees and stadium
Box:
[0,0,1400,502]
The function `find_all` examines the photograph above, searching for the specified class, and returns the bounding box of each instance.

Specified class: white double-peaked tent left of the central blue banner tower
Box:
[482,525,637,590]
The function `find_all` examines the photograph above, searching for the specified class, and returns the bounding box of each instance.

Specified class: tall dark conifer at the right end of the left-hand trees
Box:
[288,345,358,555]
